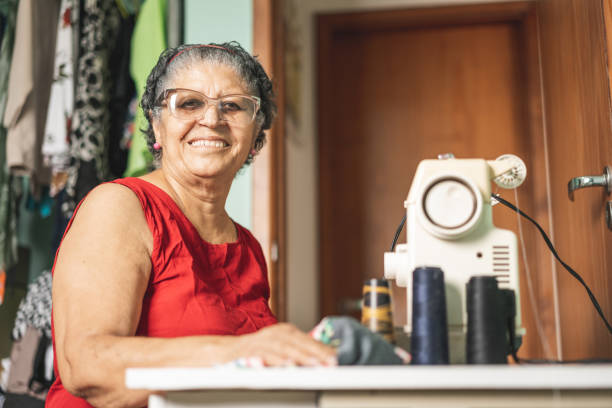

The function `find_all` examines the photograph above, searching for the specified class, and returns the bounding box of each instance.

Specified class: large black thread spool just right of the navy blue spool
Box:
[466,276,508,364]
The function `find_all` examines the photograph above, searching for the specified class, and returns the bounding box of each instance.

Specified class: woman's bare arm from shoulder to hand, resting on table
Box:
[53,184,334,406]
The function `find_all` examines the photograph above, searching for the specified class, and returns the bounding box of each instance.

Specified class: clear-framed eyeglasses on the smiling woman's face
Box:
[158,88,261,125]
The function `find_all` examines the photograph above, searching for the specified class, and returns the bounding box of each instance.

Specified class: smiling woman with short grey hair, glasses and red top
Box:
[47,43,335,408]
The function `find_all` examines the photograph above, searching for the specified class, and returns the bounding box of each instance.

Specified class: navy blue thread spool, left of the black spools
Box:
[410,267,449,364]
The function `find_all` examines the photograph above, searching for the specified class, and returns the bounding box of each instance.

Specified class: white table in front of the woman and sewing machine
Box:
[126,364,612,408]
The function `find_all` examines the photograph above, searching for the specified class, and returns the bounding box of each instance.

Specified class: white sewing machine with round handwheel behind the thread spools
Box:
[384,155,526,363]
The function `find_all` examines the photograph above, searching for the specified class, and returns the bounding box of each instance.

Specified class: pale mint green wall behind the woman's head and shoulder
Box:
[184,0,253,228]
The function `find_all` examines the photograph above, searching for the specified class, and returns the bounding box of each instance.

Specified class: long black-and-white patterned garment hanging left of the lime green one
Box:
[62,0,121,218]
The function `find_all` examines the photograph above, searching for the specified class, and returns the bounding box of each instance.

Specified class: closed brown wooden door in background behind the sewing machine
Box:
[317,2,601,358]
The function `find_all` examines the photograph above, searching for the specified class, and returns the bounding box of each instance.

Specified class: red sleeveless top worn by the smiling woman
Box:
[46,178,277,408]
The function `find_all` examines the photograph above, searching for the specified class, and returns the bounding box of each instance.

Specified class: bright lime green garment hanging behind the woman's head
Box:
[124,0,167,177]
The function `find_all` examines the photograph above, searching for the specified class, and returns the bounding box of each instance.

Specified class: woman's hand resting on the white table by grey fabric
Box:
[233,323,337,366]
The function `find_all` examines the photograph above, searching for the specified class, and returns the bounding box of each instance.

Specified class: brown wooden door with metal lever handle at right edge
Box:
[538,0,612,359]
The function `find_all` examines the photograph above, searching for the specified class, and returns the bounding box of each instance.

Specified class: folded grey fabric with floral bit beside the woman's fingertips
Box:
[310,316,410,365]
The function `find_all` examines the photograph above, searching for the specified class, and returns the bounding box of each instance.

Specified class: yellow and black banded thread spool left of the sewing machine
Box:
[361,279,395,344]
